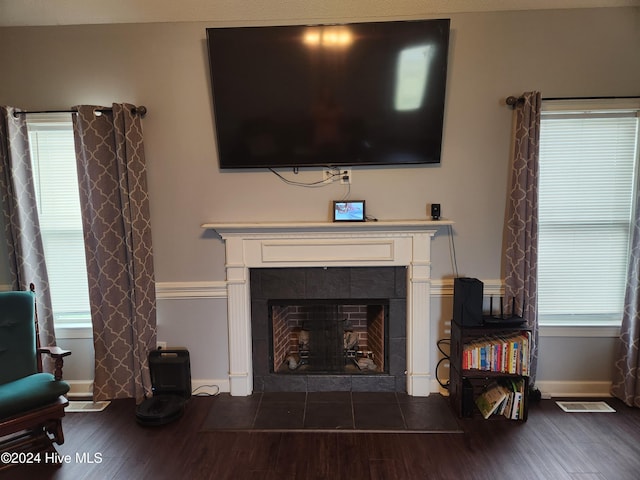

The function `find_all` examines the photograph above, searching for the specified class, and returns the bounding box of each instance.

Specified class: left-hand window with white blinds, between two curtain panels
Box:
[27,113,91,325]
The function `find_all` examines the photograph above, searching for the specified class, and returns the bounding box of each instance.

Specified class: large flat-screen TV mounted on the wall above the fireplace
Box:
[207,19,450,169]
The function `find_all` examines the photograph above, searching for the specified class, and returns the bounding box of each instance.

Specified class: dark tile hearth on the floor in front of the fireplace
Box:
[202,392,462,433]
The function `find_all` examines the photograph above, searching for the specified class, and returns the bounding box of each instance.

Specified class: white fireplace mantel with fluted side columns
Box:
[202,220,453,396]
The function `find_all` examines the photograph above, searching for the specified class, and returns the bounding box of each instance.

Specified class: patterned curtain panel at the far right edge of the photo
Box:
[611,172,640,407]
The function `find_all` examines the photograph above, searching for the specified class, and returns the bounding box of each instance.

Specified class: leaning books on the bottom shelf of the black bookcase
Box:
[476,379,526,420]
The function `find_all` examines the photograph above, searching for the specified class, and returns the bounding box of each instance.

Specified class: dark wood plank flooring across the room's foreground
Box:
[0,397,640,480]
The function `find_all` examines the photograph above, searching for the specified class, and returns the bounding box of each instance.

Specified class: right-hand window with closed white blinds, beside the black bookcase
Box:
[538,100,640,326]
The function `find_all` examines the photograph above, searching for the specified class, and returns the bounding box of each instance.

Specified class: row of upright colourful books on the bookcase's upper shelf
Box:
[462,331,531,376]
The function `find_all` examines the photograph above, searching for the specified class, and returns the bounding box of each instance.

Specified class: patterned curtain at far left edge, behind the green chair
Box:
[0,107,56,348]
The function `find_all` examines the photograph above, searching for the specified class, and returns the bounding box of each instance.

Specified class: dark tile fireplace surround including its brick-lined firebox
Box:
[250,267,407,392]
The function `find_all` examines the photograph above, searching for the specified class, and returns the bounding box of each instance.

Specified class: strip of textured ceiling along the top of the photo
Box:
[0,0,640,26]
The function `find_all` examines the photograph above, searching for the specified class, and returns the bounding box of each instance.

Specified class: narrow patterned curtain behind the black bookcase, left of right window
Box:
[505,92,542,384]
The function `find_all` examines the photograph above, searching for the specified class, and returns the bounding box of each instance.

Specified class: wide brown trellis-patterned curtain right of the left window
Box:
[74,104,156,403]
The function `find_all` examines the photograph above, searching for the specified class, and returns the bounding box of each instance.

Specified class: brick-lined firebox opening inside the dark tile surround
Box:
[268,299,389,375]
